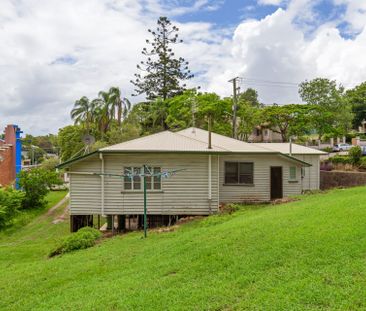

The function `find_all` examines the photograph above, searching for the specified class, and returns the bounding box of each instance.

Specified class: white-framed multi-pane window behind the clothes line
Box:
[123,166,161,190]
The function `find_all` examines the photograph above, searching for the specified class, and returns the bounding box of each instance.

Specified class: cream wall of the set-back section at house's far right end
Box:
[294,154,320,190]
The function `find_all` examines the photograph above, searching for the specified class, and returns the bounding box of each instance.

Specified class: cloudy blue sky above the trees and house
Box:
[0,0,366,135]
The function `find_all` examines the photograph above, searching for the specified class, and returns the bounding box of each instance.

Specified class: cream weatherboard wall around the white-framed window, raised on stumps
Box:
[70,154,219,215]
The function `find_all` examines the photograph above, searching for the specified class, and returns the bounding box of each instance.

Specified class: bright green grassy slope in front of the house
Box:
[0,188,366,310]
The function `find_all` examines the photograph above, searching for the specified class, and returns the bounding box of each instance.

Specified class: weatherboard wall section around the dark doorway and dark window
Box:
[219,155,302,203]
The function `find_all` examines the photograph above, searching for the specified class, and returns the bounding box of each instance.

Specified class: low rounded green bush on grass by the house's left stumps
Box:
[48,227,102,257]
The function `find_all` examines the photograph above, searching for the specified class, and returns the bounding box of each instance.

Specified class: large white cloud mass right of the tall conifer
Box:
[209,0,366,104]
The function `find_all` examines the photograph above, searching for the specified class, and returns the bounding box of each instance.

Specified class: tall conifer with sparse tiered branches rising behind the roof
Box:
[131,17,193,100]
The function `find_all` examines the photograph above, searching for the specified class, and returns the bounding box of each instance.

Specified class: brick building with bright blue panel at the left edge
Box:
[0,125,22,187]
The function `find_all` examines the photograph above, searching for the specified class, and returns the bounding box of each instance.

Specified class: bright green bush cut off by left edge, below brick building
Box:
[0,188,24,229]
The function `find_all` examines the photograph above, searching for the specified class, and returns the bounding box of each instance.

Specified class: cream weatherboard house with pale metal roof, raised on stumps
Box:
[59,128,323,232]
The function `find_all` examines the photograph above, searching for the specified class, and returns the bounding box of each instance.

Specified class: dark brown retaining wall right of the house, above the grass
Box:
[320,171,366,190]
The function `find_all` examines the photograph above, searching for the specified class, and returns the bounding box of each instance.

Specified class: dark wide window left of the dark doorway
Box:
[225,162,253,184]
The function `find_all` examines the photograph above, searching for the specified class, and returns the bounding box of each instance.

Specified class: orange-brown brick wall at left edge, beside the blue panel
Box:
[0,125,16,186]
